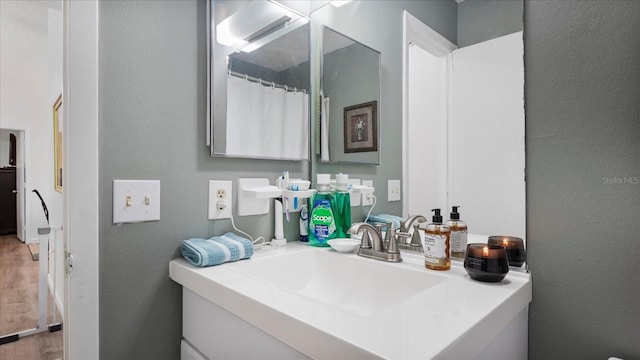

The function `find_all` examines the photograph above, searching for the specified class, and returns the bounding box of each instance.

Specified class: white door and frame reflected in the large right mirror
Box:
[403,1,526,239]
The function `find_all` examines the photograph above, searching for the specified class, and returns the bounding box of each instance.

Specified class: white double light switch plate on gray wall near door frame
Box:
[113,180,160,224]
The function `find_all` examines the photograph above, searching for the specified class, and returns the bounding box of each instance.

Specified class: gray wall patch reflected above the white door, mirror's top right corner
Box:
[457,0,523,47]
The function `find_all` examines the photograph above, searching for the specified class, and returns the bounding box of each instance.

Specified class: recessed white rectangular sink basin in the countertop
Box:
[234,248,446,316]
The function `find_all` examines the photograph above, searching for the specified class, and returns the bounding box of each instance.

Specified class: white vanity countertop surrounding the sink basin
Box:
[169,242,532,359]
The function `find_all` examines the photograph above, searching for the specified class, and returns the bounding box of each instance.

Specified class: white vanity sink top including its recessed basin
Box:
[169,243,531,359]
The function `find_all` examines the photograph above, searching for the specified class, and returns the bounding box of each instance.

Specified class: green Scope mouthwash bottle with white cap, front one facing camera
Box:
[309,174,336,247]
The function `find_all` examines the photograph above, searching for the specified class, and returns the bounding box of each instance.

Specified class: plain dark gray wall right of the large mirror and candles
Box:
[524,0,640,359]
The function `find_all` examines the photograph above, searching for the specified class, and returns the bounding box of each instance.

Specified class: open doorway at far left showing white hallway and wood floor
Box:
[0,0,64,359]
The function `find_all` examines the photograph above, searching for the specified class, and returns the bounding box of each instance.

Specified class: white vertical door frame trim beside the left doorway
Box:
[63,0,100,360]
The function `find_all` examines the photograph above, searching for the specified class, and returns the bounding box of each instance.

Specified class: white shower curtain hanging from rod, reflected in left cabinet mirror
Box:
[226,76,309,159]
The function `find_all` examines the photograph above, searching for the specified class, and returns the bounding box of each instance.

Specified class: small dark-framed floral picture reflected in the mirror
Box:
[344,101,378,153]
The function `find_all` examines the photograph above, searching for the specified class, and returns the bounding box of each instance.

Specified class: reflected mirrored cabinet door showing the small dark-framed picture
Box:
[320,26,380,164]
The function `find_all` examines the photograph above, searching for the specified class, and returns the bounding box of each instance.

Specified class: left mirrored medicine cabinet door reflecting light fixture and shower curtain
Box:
[208,0,310,160]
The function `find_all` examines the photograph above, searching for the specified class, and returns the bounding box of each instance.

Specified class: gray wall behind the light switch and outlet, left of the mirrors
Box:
[99,0,309,360]
